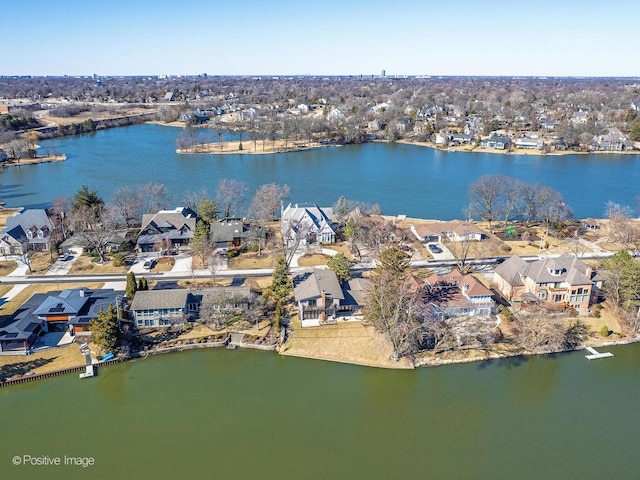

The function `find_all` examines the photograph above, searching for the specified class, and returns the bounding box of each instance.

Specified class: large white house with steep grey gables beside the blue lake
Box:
[280,203,338,245]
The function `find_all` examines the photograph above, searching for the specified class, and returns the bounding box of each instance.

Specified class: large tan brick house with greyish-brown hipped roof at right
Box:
[494,254,603,309]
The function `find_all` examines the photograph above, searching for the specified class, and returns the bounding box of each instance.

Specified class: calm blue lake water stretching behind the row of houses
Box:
[0,124,640,219]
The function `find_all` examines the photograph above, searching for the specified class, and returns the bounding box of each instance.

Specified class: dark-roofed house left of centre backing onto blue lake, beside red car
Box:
[136,207,197,252]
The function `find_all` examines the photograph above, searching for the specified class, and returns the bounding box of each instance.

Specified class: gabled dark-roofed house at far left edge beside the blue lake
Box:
[0,209,54,255]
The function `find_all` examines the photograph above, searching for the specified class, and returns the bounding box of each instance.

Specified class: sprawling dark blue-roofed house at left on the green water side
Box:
[0,288,125,355]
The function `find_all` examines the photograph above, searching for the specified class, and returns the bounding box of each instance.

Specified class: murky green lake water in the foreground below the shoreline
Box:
[0,345,640,480]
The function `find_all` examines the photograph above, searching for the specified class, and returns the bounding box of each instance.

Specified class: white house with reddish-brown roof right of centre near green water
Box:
[424,270,496,319]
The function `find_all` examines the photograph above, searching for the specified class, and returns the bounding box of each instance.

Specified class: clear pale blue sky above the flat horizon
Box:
[0,0,640,76]
